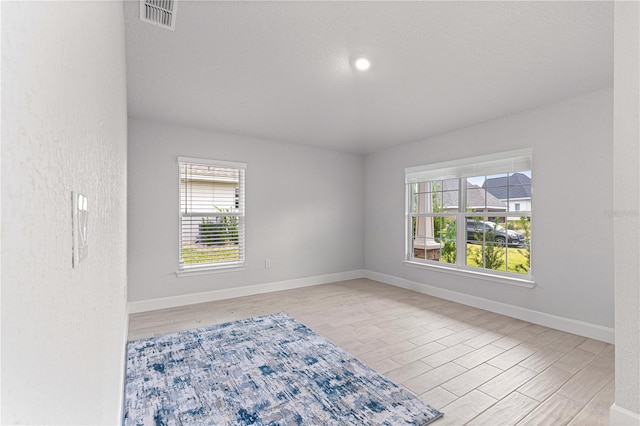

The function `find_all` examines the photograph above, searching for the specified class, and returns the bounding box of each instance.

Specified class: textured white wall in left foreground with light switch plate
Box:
[1,2,127,424]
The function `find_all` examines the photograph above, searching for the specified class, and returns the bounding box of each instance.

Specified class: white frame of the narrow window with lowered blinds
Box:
[176,157,247,277]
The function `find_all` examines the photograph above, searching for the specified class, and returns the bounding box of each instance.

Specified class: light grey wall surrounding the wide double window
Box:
[365,89,614,327]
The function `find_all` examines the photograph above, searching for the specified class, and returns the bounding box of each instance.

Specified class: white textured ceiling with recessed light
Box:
[125,0,613,154]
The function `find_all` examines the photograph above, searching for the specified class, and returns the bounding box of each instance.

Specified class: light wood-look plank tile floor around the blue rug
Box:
[129,279,614,426]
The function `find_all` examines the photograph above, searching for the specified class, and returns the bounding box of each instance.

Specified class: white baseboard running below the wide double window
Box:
[365,270,615,344]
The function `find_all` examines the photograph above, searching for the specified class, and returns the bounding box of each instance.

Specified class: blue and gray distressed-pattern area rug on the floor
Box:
[123,313,442,426]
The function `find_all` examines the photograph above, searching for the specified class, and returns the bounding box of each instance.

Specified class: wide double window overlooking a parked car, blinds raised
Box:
[405,150,532,281]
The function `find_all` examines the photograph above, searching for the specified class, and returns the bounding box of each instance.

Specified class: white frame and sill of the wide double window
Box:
[404,148,535,288]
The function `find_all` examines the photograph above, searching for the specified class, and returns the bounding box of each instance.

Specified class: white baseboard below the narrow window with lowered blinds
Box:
[127,269,365,314]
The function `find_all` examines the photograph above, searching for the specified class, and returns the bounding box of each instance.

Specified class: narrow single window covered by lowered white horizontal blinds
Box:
[178,157,246,274]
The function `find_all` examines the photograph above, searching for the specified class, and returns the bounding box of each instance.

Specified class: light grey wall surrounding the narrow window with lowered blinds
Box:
[128,120,364,301]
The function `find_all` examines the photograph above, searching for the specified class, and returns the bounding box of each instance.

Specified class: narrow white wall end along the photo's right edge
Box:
[611,2,640,425]
